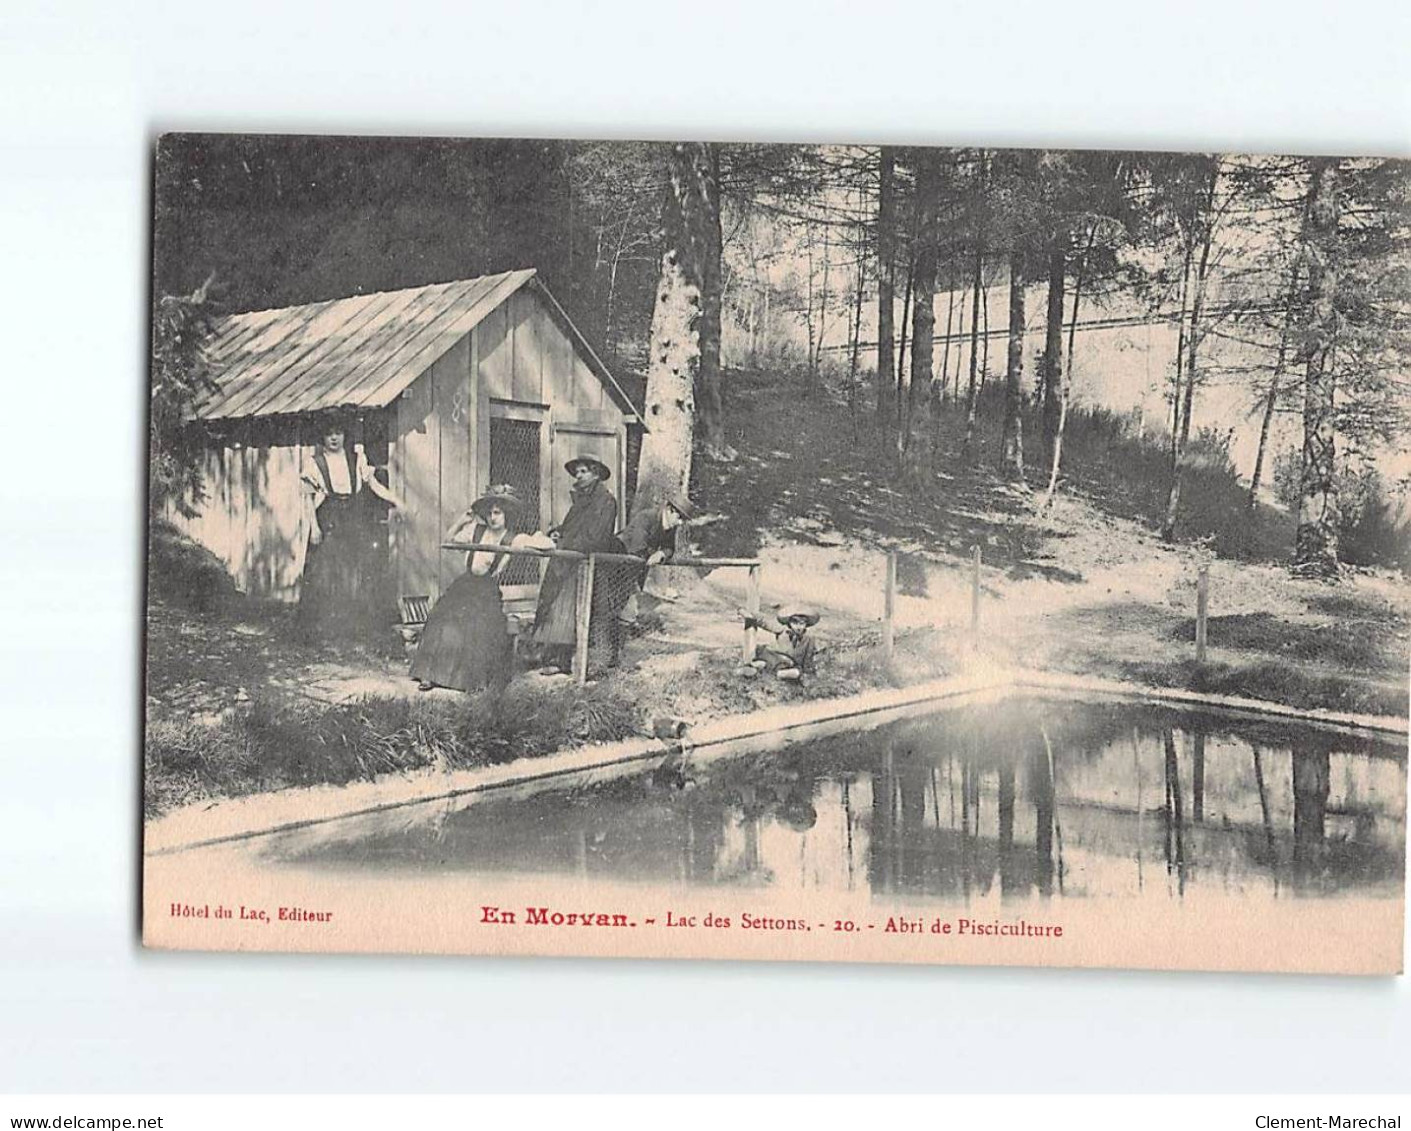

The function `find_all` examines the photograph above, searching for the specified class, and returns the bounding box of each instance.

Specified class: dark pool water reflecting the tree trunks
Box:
[256,691,1407,898]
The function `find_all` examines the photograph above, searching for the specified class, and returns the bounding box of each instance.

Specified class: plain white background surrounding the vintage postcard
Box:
[0,0,1411,1094]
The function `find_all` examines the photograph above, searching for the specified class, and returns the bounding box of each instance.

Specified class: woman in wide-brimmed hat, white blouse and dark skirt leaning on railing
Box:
[412,485,547,691]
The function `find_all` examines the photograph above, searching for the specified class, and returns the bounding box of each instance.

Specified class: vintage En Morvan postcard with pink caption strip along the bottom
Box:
[143,134,1411,974]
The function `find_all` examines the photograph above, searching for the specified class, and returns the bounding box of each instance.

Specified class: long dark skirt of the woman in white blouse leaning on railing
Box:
[412,571,514,691]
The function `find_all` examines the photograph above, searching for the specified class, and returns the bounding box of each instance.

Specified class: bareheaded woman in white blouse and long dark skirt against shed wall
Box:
[299,417,402,639]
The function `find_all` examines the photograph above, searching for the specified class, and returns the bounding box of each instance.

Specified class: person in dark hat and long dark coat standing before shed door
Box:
[532,456,622,671]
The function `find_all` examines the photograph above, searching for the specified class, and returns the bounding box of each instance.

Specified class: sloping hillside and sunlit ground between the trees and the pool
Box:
[693,374,1411,715]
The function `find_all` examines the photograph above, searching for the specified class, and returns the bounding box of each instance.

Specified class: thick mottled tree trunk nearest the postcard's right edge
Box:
[1294,158,1340,578]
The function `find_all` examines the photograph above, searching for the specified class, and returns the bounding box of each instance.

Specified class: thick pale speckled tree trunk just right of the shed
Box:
[634,142,713,511]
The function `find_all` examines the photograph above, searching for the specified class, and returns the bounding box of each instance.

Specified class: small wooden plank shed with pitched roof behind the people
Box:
[169,269,641,601]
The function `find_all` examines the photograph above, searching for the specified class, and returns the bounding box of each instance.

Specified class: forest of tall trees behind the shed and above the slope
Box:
[154,135,1411,577]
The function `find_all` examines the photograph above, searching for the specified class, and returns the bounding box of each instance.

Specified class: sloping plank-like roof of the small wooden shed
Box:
[195,269,635,420]
